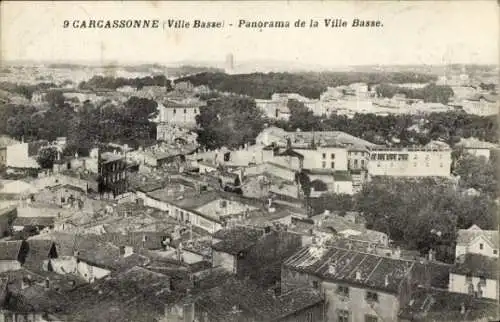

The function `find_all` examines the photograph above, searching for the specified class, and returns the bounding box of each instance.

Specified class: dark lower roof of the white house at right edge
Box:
[451,254,498,280]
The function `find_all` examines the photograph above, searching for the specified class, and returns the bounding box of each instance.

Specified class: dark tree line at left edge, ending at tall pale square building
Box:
[0,91,157,155]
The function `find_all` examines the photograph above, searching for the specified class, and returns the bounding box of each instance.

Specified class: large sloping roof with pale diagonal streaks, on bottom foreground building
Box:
[284,246,413,293]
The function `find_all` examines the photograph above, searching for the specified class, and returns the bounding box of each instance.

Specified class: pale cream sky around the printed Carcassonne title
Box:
[0,1,500,66]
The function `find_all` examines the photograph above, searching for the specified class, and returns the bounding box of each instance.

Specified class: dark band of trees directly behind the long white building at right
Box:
[267,110,498,146]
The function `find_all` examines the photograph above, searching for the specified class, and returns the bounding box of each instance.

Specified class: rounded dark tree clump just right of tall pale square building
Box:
[196,96,264,149]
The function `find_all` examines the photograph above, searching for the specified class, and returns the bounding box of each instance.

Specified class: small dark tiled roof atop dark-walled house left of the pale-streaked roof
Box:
[212,227,264,255]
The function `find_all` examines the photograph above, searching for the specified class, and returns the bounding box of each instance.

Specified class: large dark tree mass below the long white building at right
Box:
[355,178,497,262]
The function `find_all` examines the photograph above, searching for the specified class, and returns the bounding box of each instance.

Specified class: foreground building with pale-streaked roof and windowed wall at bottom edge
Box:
[281,244,425,322]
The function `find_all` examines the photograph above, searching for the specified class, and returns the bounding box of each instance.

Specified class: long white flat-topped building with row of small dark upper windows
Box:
[368,147,452,177]
